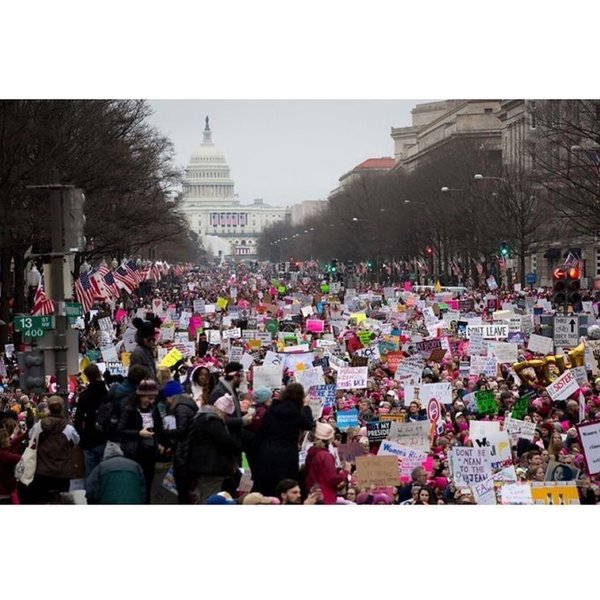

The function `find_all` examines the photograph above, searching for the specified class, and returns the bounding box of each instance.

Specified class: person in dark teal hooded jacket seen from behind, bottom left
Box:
[85,442,146,504]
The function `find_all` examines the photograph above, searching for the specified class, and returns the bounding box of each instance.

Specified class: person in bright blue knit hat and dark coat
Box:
[162,381,198,504]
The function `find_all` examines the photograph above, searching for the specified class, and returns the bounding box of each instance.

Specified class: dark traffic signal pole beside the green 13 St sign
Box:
[50,169,69,413]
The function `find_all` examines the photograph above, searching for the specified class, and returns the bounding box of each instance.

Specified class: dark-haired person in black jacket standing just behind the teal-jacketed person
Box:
[73,363,108,478]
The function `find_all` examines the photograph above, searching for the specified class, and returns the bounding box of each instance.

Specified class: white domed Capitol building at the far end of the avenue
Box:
[181,117,292,258]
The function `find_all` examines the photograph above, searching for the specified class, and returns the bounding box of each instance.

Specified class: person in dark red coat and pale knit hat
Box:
[305,423,352,504]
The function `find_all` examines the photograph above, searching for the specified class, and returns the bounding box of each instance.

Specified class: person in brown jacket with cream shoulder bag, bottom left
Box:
[24,396,79,504]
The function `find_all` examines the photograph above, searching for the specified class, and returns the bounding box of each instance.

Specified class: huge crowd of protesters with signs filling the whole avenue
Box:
[0,262,600,505]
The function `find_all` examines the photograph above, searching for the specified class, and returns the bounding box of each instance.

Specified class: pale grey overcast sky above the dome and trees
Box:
[150,100,434,206]
